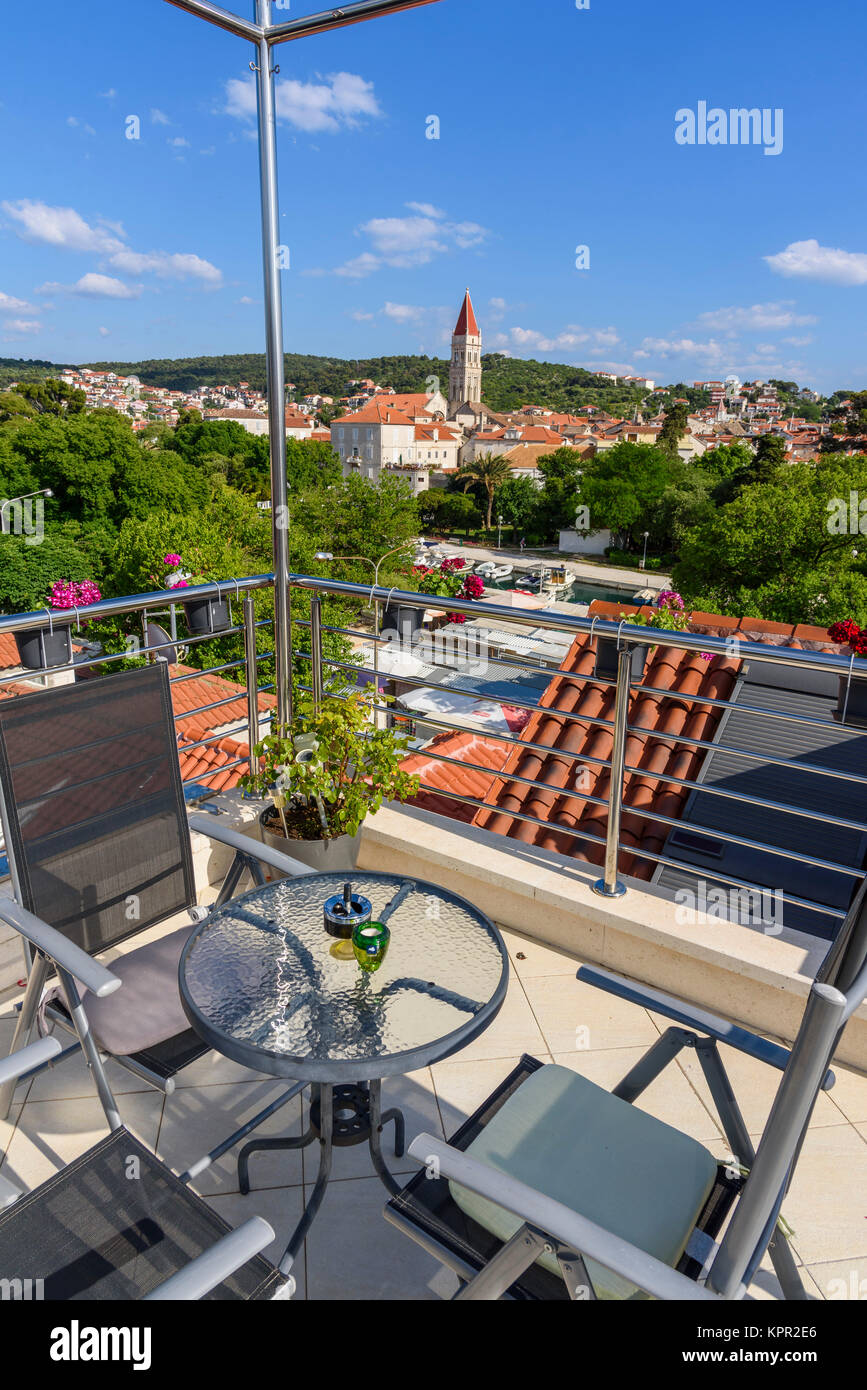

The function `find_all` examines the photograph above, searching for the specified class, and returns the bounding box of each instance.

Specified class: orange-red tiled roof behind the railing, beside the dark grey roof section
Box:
[404,602,839,880]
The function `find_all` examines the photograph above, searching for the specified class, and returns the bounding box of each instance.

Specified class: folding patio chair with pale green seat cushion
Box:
[385,880,867,1300]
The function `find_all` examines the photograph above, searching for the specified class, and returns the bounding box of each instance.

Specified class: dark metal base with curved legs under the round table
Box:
[238,1081,406,1273]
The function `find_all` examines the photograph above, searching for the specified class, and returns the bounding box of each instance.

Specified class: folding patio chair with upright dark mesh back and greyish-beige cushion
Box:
[0,662,311,1170]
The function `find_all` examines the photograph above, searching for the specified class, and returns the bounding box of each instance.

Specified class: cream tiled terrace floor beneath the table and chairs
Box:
[0,933,867,1300]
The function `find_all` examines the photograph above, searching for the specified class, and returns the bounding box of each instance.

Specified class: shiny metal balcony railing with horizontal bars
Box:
[0,574,867,939]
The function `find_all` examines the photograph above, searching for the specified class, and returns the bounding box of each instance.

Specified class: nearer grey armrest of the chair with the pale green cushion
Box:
[408,1134,720,1302]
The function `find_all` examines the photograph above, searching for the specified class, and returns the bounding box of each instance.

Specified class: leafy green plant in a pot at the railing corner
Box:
[240,687,420,873]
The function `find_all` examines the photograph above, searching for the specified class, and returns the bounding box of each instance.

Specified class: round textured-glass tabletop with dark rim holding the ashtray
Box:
[181,872,509,1084]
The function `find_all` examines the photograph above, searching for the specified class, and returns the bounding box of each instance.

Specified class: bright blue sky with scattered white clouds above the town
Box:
[0,0,867,391]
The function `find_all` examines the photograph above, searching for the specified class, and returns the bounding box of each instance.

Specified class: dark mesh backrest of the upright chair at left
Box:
[0,662,196,954]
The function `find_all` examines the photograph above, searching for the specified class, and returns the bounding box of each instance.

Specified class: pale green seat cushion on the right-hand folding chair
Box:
[449,1065,717,1298]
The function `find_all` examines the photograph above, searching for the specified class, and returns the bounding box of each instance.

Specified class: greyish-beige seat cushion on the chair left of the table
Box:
[83,924,196,1056]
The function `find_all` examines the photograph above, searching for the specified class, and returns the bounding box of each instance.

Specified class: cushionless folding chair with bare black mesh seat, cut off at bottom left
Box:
[0,1038,295,1301]
